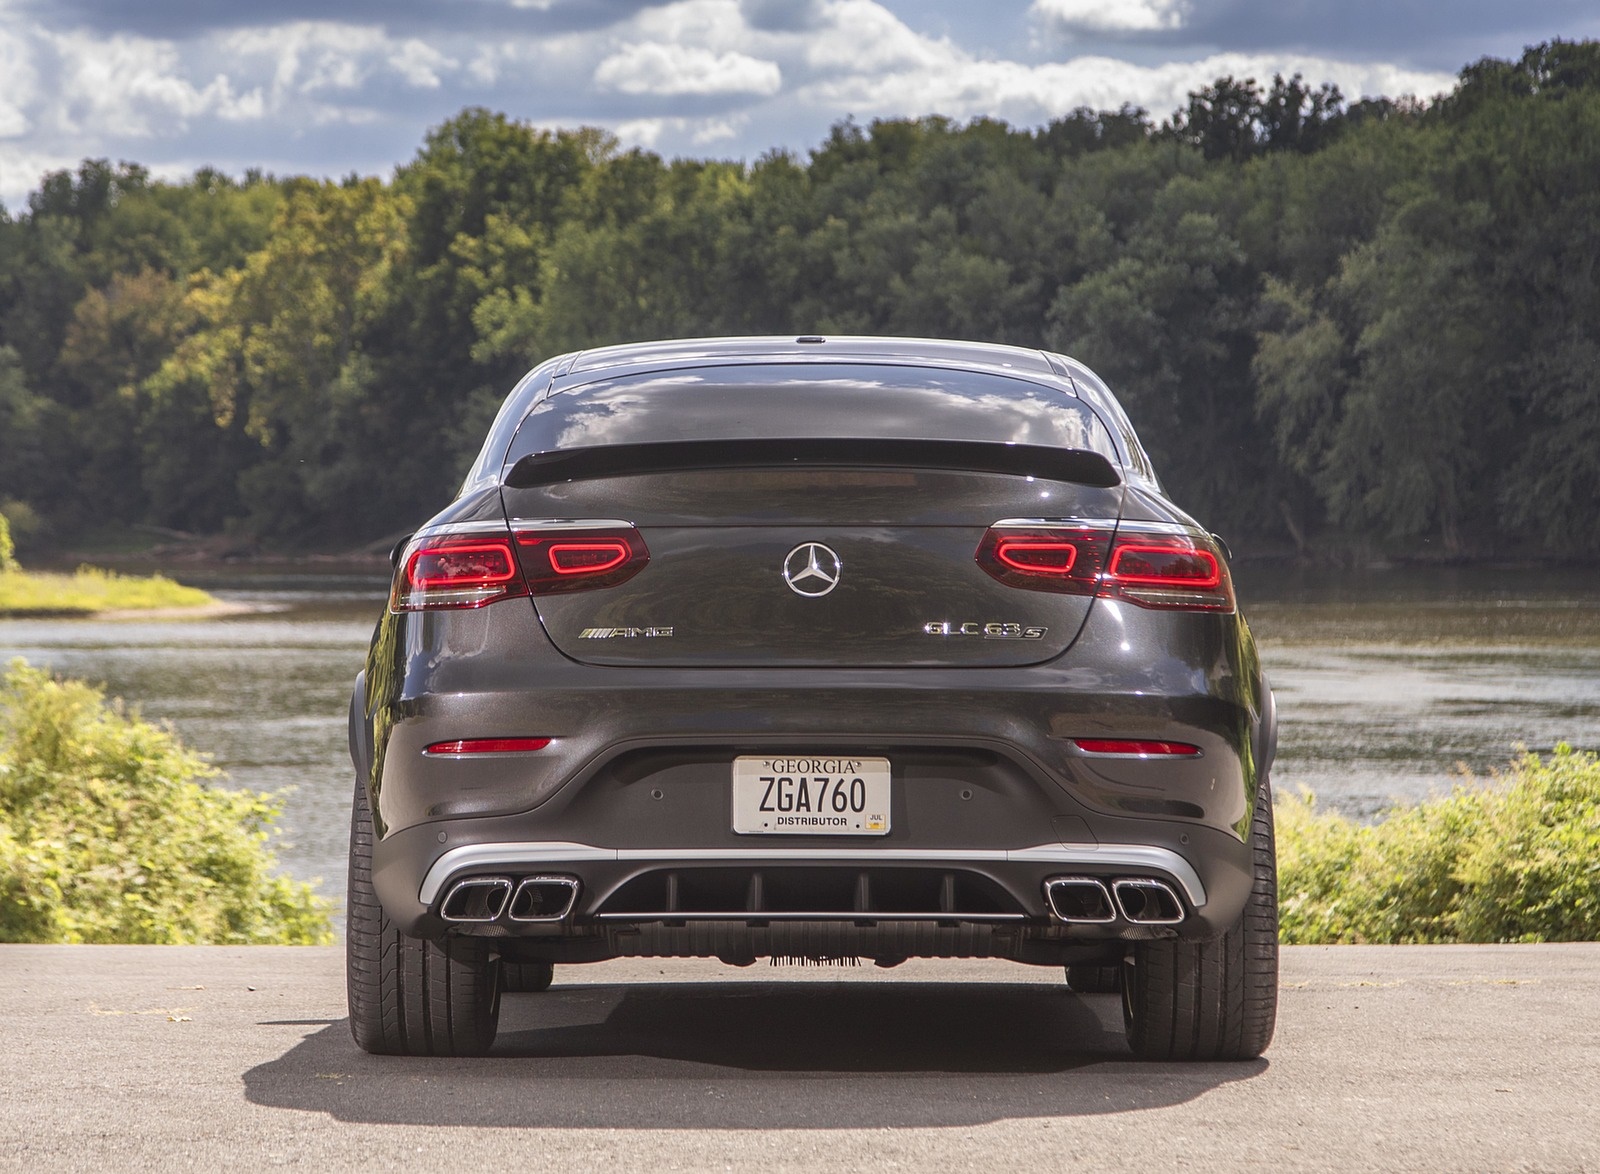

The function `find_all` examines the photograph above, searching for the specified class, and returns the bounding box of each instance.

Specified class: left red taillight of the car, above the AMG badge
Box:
[389,523,650,611]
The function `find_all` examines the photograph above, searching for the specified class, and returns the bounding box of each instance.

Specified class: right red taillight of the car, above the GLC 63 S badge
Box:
[974,521,1235,611]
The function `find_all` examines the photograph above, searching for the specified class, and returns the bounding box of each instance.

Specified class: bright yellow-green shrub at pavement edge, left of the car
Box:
[0,661,331,945]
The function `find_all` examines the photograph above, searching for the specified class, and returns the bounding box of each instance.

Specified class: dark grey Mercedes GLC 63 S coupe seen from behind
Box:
[347,337,1277,1059]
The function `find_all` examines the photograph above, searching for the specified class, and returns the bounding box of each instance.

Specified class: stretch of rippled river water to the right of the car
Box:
[1238,568,1600,816]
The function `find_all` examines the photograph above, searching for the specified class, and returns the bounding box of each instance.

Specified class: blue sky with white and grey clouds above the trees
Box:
[0,0,1600,213]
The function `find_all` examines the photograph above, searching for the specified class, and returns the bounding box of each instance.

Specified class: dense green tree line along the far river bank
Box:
[0,42,1600,557]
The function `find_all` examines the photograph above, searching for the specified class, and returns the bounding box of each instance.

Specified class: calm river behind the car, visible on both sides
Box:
[0,565,1600,897]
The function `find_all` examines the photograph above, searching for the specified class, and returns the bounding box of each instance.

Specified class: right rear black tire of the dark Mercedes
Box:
[1122,776,1278,1060]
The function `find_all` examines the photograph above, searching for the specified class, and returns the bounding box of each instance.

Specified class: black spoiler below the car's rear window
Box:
[506,437,1122,489]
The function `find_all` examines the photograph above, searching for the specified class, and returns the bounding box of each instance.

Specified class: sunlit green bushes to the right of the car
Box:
[1277,744,1600,944]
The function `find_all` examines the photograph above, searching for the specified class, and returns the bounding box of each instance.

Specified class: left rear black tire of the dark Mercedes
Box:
[344,781,499,1056]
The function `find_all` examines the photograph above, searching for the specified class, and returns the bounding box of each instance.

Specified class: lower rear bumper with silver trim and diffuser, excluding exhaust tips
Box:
[373,806,1251,961]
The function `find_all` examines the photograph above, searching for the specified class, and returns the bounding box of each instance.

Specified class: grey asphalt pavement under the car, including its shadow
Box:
[0,944,1600,1174]
